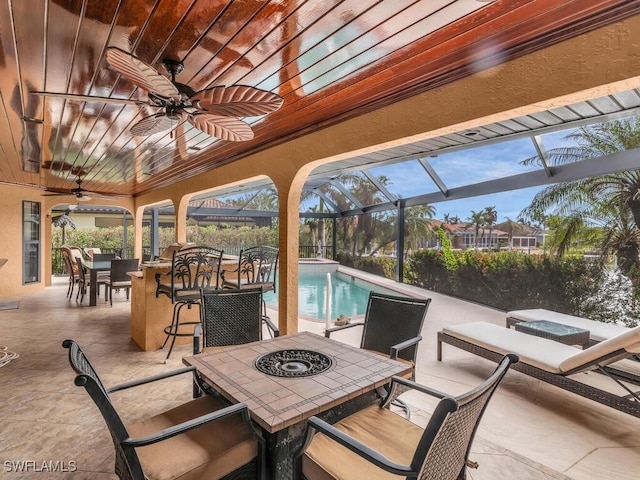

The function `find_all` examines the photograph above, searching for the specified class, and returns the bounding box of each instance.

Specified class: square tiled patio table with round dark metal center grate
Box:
[183,332,411,480]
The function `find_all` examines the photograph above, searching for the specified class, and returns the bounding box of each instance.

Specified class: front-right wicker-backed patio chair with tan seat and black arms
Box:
[294,354,518,480]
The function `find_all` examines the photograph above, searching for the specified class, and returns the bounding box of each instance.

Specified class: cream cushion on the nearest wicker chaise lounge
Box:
[443,322,640,374]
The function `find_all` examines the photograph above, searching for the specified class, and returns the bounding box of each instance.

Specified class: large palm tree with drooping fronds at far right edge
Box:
[520,118,640,285]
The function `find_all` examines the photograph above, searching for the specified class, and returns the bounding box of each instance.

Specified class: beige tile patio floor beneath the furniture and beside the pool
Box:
[0,278,640,480]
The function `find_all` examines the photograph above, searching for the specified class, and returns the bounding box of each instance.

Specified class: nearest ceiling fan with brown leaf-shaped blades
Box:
[33,47,283,142]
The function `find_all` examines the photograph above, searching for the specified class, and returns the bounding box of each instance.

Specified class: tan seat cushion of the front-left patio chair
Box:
[129,396,258,480]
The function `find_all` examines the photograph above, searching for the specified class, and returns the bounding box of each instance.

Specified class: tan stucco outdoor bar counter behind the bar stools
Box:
[129,255,238,351]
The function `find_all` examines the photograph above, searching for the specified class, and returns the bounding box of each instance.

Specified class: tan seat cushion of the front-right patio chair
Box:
[302,405,423,480]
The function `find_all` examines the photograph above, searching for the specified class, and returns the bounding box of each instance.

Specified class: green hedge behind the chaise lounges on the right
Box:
[405,250,639,326]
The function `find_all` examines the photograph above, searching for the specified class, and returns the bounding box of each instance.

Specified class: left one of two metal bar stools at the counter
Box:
[155,247,223,363]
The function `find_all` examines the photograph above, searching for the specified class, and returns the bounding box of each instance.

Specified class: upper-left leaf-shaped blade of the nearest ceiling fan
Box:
[107,47,180,100]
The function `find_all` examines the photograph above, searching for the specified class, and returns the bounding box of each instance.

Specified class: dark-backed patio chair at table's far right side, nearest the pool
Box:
[324,292,431,418]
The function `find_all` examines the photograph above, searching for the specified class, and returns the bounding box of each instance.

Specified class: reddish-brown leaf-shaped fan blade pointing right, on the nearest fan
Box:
[190,85,283,117]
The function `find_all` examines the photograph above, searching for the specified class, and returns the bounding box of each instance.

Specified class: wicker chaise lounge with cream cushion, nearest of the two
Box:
[438,322,640,417]
